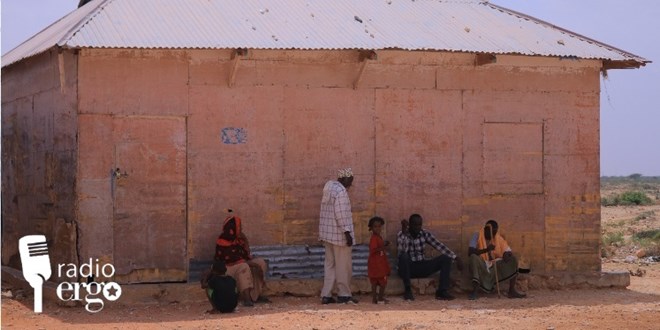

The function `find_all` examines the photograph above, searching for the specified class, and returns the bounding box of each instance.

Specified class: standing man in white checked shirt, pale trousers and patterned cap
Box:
[319,168,357,305]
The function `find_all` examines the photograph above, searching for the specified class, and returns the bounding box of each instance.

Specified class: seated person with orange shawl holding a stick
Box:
[468,220,525,300]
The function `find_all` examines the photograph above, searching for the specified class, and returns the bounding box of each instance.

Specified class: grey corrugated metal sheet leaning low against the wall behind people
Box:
[188,244,396,282]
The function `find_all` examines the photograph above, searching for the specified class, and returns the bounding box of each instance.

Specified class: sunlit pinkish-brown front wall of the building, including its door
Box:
[3,49,601,281]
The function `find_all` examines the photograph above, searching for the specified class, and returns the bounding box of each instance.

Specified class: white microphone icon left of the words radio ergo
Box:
[18,235,51,313]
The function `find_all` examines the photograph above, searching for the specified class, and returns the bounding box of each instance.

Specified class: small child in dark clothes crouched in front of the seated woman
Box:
[201,260,238,314]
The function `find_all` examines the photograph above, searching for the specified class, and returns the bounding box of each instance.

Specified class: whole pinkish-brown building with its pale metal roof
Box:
[2,0,649,282]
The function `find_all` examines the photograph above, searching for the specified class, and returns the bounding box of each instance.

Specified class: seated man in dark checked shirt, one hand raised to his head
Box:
[396,214,463,300]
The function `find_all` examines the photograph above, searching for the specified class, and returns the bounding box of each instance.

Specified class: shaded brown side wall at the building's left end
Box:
[2,51,78,277]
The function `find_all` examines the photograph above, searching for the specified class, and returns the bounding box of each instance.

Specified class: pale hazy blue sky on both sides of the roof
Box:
[1,0,660,176]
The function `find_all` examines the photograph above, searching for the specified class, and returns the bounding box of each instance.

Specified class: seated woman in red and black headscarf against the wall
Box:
[215,210,270,306]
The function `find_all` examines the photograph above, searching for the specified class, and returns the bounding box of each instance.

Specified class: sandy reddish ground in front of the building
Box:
[2,263,660,330]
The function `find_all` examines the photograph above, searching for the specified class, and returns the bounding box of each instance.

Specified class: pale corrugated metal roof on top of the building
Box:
[3,0,650,67]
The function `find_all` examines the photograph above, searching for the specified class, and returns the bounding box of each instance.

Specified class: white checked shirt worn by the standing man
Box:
[319,180,355,246]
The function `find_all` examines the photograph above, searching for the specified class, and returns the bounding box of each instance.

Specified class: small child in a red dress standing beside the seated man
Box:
[367,217,390,304]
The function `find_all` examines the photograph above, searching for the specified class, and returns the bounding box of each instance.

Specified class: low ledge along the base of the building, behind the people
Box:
[2,266,630,306]
